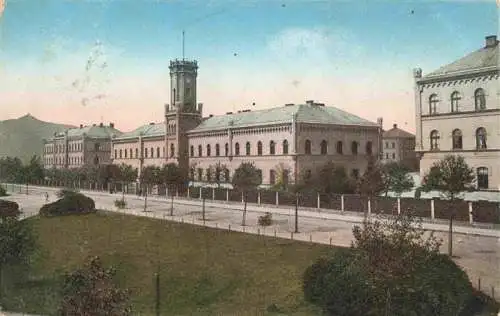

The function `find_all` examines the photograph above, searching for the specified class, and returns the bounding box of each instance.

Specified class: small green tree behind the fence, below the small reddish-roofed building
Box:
[382,162,415,197]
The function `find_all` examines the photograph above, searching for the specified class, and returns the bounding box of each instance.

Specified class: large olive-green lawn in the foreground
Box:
[1,212,334,315]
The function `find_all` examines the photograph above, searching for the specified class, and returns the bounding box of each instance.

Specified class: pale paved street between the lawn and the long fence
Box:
[3,183,500,293]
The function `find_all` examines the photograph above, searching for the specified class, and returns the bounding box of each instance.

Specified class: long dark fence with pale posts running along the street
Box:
[3,181,500,224]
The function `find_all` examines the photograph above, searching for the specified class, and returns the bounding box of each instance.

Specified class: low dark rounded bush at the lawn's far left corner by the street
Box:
[40,192,95,216]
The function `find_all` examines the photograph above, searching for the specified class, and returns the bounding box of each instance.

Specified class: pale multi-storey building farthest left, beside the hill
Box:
[43,123,122,169]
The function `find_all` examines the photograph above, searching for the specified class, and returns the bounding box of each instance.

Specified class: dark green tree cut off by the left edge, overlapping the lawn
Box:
[0,201,36,297]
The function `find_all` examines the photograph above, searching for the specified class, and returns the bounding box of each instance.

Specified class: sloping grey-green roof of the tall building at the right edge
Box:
[423,42,499,79]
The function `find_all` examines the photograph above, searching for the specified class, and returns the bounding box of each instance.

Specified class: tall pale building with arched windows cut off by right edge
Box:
[414,36,500,190]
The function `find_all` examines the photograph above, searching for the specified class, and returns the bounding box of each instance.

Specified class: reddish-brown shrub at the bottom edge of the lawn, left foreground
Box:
[59,257,131,316]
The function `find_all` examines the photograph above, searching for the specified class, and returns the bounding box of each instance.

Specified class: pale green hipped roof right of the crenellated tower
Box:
[190,104,378,132]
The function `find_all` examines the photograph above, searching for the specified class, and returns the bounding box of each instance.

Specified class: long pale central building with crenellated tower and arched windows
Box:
[113,60,382,185]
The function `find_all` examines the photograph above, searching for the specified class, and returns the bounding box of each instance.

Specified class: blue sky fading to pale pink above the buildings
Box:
[0,0,500,132]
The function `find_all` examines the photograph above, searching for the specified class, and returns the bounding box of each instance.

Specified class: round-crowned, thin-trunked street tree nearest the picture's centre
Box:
[232,162,262,226]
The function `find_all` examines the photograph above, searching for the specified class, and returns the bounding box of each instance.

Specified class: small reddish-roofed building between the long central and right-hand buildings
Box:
[382,124,418,170]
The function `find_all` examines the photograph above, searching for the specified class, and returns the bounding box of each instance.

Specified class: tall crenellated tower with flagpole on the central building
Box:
[165,59,203,177]
